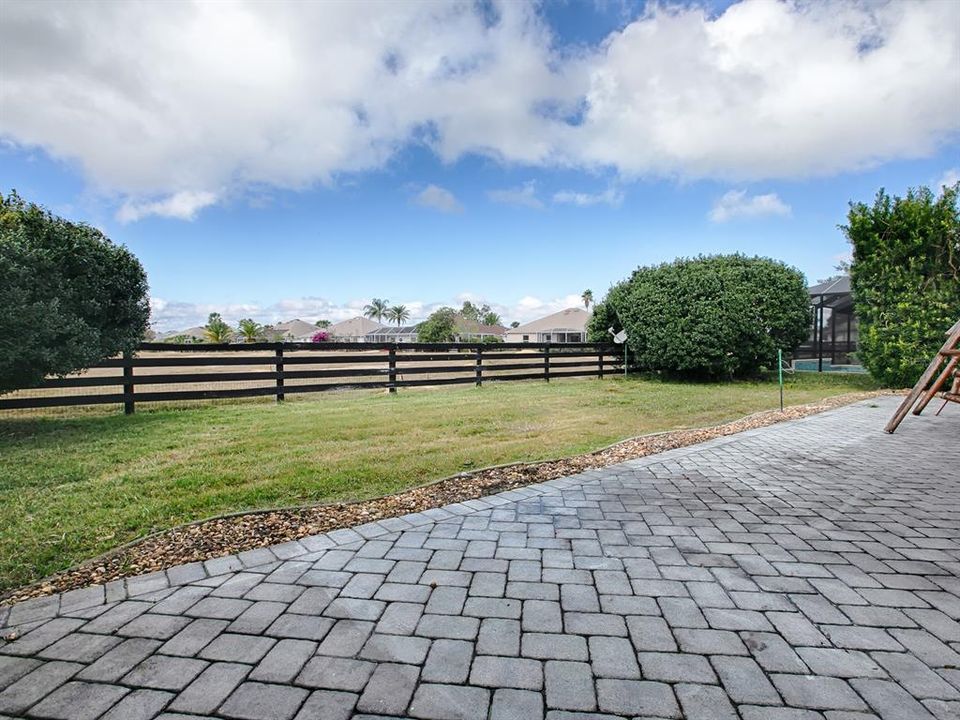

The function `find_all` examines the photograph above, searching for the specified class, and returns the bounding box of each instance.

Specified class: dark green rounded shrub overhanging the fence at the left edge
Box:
[0,193,150,392]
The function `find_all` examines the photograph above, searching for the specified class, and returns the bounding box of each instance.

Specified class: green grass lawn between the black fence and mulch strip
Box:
[0,374,874,590]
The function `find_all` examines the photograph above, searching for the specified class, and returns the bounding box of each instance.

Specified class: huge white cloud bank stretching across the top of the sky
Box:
[0,0,960,214]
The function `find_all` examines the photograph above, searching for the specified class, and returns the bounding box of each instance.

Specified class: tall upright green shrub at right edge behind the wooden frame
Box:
[841,183,960,387]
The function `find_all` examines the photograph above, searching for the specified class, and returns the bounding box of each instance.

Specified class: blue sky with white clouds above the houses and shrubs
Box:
[0,0,960,332]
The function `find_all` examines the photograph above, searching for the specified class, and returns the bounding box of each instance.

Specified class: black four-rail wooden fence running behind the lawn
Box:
[0,343,624,414]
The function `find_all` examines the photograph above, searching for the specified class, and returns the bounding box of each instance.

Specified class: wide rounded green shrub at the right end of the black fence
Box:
[589,255,810,379]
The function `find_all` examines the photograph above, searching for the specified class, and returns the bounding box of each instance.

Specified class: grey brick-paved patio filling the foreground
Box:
[0,398,960,720]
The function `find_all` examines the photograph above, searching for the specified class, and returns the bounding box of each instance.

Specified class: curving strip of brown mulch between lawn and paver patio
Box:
[0,392,884,605]
